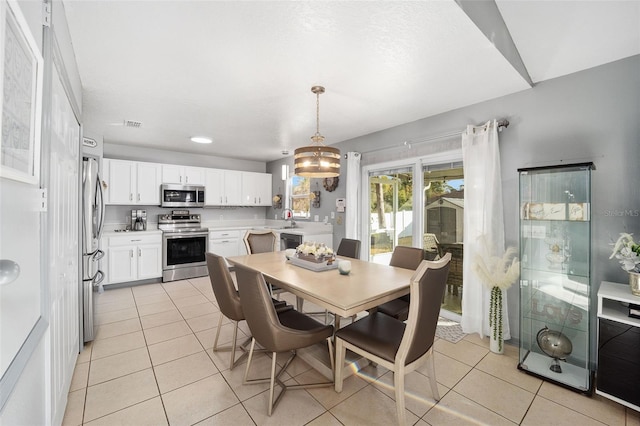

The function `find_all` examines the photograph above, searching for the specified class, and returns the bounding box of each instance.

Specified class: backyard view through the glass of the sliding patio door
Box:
[369,164,464,314]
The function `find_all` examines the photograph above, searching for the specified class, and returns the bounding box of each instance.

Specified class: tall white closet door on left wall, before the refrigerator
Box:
[48,61,81,419]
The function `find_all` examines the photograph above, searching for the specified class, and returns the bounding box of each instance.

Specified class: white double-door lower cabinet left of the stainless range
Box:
[106,232,162,284]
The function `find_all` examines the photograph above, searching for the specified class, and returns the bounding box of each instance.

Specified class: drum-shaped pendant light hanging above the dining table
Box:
[293,86,340,178]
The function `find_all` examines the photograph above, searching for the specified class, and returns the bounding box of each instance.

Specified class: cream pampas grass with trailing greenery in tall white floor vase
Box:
[473,237,520,354]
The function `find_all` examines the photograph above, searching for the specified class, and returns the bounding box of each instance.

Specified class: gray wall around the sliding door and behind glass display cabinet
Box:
[267,56,640,337]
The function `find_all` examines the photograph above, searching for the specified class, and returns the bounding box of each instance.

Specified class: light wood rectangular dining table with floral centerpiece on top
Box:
[227,251,415,377]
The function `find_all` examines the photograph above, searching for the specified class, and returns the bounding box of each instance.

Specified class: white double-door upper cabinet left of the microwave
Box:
[103,158,160,205]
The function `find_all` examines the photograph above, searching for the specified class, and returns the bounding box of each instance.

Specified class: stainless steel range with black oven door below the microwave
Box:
[158,210,209,282]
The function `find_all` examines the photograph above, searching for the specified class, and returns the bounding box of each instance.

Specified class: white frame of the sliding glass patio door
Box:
[360,148,464,321]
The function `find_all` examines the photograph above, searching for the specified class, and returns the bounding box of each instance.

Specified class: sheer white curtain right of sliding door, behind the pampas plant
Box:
[461,120,511,340]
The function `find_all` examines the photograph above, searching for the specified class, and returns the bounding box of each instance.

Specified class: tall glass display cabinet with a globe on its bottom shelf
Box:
[518,163,594,393]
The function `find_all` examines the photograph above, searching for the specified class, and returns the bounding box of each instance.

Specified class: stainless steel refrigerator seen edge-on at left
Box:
[80,157,104,342]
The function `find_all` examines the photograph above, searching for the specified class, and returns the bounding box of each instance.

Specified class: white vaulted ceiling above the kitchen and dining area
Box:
[64,0,640,161]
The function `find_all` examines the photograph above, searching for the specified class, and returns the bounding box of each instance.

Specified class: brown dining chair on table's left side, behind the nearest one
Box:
[205,253,293,370]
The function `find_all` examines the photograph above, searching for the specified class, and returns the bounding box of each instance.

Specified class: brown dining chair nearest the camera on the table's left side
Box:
[236,265,335,416]
